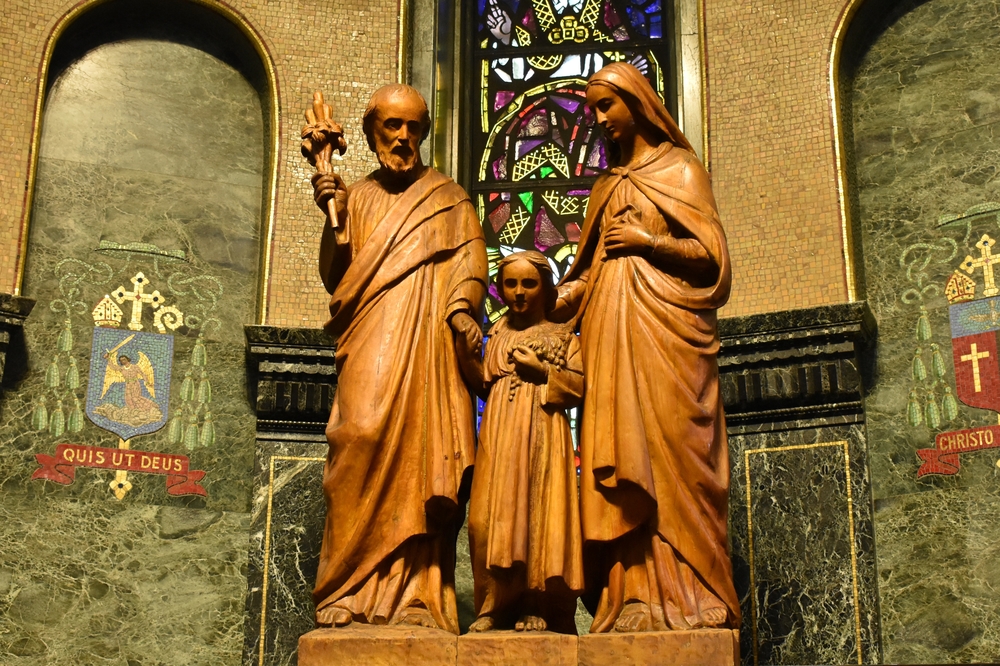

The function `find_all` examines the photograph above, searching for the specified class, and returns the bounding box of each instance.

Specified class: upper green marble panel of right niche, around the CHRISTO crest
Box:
[850,0,1000,498]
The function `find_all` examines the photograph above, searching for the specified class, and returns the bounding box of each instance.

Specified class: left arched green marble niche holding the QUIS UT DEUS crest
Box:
[0,0,276,510]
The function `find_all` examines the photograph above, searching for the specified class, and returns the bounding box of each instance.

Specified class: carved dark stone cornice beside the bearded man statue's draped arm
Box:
[244,326,337,433]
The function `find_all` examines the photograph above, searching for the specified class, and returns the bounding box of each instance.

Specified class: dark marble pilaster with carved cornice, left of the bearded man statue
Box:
[243,326,337,666]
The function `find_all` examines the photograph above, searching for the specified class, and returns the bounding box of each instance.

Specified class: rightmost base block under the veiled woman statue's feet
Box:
[578,629,740,666]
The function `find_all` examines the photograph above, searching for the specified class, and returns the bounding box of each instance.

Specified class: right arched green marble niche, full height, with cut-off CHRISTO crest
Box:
[837,0,1000,663]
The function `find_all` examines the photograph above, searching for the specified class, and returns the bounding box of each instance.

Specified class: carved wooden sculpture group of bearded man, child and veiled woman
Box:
[303,63,740,634]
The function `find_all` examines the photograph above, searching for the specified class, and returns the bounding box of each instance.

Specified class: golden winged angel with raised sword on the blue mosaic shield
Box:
[94,337,163,428]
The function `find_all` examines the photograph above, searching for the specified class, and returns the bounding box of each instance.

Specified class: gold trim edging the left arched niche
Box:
[14,0,282,324]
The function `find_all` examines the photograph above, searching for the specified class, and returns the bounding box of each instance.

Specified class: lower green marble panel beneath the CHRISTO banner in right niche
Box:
[875,481,1000,664]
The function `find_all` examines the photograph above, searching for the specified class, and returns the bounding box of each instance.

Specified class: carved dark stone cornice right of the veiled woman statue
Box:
[719,301,876,432]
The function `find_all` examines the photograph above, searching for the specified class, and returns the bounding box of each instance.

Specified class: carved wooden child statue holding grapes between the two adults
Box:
[460,252,583,634]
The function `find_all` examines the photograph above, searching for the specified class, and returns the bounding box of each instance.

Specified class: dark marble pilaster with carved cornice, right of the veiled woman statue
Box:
[719,303,881,665]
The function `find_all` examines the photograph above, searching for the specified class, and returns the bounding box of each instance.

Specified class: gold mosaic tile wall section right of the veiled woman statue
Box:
[704,0,848,316]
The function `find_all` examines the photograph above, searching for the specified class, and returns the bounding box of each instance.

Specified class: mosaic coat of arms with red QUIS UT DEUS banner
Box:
[32,272,207,499]
